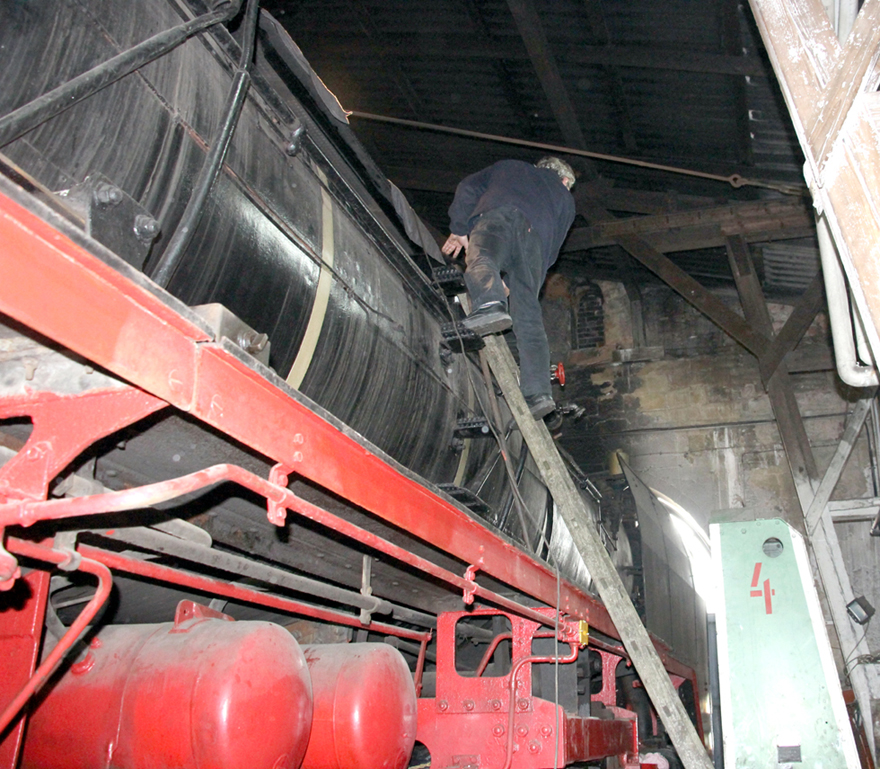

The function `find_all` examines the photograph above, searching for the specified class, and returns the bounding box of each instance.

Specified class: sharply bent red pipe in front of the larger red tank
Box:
[0,537,113,734]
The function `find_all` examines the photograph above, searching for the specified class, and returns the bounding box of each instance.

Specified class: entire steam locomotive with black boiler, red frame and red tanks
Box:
[0,0,699,769]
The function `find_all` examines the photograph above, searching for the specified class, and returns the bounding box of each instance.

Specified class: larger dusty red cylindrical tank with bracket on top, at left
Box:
[21,601,312,769]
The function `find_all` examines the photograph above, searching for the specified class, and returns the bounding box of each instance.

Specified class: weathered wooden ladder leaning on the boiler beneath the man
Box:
[485,336,713,769]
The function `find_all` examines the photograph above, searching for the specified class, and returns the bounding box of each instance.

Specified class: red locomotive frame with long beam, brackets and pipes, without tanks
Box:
[0,181,699,769]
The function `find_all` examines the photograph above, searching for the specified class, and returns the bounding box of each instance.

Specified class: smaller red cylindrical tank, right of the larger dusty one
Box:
[302,643,417,769]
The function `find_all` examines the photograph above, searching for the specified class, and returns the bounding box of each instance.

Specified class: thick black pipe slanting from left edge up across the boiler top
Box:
[0,0,241,147]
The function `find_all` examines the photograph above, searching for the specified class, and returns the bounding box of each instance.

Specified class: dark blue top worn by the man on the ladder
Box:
[449,160,574,273]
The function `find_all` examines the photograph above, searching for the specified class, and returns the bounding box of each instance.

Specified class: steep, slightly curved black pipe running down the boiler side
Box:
[150,0,260,288]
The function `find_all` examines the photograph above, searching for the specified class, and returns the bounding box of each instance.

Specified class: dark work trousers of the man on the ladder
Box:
[464,207,551,396]
